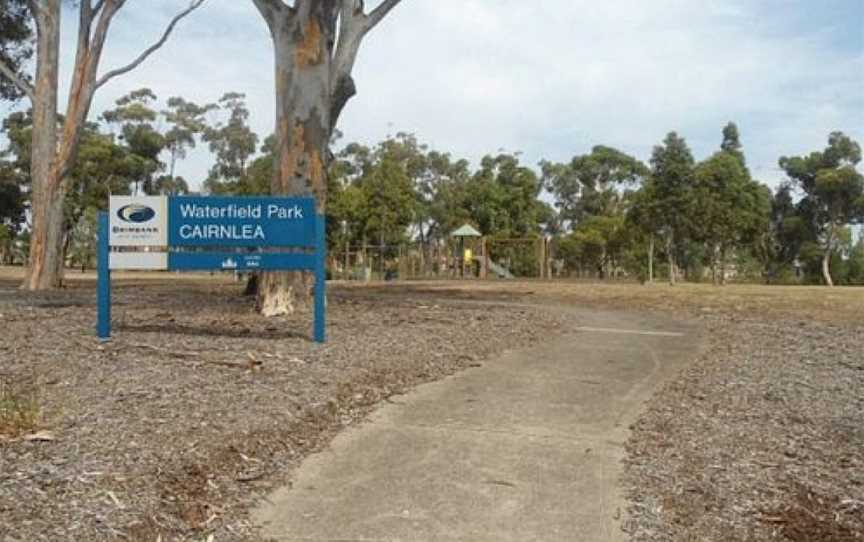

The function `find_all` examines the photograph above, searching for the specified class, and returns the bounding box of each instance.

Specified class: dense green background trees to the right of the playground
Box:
[542,123,864,284]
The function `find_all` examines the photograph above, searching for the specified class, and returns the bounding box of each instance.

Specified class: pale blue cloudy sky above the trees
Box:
[1,0,864,191]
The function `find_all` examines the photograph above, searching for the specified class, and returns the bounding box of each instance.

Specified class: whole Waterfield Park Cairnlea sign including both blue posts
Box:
[97,196,327,343]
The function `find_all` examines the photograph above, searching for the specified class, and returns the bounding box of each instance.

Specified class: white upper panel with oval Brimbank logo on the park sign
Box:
[108,196,168,247]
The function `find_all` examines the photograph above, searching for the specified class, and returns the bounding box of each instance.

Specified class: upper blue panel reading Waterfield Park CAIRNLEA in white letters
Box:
[168,196,315,248]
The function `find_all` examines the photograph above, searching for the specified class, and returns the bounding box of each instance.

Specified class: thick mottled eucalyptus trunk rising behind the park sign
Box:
[252,0,400,316]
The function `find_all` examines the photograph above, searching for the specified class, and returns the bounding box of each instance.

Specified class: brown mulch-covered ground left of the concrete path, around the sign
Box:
[0,270,558,542]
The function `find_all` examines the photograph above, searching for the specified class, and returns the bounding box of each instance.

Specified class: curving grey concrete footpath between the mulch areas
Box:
[253,309,701,542]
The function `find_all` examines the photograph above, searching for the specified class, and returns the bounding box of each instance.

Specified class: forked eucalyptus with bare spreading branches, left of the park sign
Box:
[0,0,205,290]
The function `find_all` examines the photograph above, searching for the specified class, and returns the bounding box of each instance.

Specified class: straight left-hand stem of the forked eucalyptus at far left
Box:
[21,0,65,290]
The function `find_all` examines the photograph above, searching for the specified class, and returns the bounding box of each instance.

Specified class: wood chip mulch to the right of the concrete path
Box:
[625,315,864,542]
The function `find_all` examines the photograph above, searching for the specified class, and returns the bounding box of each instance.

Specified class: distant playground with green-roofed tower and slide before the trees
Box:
[328,226,555,282]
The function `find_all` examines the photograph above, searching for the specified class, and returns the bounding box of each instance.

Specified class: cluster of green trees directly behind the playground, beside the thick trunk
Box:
[327,139,554,252]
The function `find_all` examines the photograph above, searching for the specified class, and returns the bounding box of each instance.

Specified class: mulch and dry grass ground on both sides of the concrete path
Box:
[0,271,864,542]
